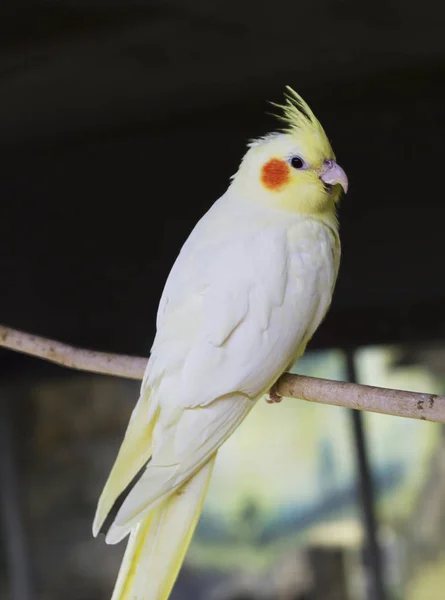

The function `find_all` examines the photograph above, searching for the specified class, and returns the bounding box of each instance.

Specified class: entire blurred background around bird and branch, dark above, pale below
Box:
[0,0,445,600]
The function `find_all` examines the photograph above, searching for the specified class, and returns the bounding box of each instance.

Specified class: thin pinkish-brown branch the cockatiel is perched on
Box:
[0,326,445,423]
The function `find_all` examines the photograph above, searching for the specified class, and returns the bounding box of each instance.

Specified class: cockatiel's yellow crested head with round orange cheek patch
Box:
[232,87,348,220]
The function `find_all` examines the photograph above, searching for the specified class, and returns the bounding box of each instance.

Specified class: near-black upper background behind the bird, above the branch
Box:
[0,0,445,373]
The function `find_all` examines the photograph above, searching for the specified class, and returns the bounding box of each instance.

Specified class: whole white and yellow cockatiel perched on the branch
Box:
[93,87,348,600]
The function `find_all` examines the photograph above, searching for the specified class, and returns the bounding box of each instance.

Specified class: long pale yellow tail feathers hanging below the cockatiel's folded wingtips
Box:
[112,453,216,600]
